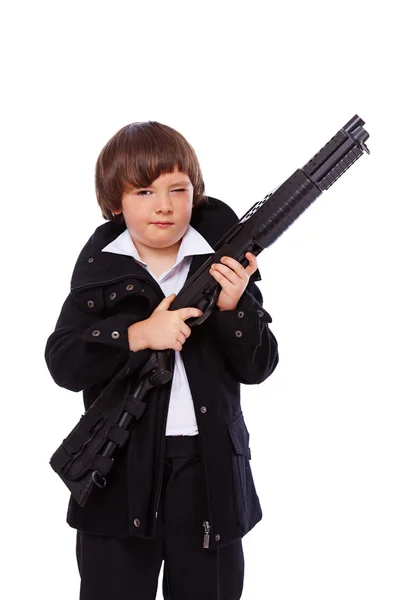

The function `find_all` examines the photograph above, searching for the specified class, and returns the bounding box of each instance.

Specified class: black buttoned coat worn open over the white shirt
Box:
[45,197,278,548]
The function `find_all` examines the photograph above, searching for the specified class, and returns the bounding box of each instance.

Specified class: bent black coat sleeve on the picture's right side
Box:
[209,278,279,384]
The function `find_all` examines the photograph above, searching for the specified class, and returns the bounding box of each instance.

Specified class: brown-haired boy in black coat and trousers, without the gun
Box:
[45,121,278,600]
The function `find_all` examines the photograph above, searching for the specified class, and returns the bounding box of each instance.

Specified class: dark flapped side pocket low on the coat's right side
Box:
[228,413,262,533]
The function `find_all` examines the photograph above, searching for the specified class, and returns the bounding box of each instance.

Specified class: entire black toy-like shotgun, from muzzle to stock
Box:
[50,115,369,506]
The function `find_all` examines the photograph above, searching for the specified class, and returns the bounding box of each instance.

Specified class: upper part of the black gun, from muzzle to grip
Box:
[170,115,368,316]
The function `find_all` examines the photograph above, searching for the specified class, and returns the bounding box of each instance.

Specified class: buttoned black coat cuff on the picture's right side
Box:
[211,290,272,346]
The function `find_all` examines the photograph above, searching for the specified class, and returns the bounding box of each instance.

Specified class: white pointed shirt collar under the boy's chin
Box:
[102,225,215,266]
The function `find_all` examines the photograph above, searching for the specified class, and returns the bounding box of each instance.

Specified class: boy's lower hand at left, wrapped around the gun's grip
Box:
[128,294,203,352]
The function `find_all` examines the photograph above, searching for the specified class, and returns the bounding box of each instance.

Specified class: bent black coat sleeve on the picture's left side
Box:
[45,293,151,392]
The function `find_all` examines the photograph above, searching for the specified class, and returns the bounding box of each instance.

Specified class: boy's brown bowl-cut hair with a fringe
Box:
[95,121,208,223]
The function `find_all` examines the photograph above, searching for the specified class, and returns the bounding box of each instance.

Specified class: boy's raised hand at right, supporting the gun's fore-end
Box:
[209,252,258,310]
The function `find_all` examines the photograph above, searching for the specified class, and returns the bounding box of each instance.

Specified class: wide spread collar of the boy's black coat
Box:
[71,196,261,291]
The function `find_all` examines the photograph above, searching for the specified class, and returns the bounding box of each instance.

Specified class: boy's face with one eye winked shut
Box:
[114,169,193,258]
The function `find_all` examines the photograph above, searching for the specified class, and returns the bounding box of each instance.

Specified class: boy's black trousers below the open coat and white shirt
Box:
[77,436,244,600]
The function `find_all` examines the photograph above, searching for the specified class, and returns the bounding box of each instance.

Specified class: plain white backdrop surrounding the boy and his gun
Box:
[0,0,400,600]
